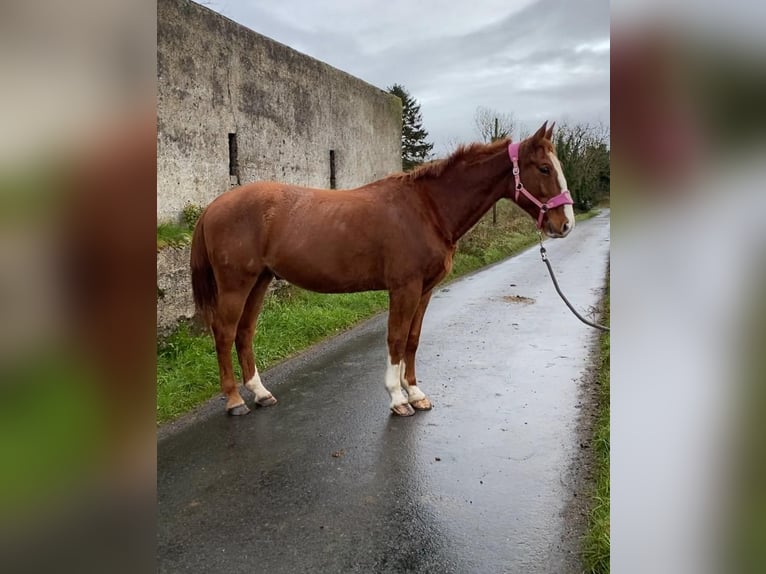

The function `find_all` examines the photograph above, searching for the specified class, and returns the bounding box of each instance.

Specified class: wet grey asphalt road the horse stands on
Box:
[157,212,609,573]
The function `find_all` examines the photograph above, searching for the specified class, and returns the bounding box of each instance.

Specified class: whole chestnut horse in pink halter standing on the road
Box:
[191,122,575,416]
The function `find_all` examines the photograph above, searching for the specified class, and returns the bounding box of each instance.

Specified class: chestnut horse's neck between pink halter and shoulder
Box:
[428,152,511,243]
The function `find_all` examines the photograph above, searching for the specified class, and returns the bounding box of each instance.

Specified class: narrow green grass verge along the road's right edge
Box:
[582,290,609,574]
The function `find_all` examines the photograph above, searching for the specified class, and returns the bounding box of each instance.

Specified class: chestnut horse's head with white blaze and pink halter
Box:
[508,122,575,237]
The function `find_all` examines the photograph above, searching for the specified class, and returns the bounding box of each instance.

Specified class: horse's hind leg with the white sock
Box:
[236,271,277,407]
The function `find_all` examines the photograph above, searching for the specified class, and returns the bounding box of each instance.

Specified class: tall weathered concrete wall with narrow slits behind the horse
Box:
[157,0,401,221]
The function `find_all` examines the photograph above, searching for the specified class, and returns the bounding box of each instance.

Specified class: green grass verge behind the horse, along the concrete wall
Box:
[157,202,600,423]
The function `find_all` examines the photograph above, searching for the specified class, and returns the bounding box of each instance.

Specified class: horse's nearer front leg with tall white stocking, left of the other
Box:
[386,282,421,417]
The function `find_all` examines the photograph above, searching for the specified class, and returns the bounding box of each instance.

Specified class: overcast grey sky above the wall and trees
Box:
[202,0,609,156]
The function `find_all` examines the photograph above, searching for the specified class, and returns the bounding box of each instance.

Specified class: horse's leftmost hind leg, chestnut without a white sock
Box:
[211,288,250,415]
